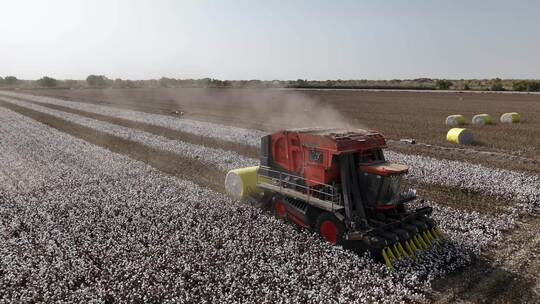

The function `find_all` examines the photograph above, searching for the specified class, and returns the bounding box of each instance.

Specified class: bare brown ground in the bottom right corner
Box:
[433,216,540,304]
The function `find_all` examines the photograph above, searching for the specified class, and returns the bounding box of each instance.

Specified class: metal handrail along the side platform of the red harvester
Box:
[257,166,342,209]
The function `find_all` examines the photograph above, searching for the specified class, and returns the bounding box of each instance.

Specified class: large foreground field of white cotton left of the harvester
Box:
[0,110,422,302]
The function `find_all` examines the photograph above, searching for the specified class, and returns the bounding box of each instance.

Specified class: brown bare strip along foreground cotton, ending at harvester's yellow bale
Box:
[0,100,225,192]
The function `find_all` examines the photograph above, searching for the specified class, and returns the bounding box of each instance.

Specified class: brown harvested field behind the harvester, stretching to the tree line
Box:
[16,89,540,174]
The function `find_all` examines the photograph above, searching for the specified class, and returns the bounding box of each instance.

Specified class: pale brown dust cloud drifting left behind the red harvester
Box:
[93,88,366,132]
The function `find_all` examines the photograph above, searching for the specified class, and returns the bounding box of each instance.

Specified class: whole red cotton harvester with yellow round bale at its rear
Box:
[225,129,442,267]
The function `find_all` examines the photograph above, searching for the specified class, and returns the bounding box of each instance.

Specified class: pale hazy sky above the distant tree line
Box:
[0,0,540,79]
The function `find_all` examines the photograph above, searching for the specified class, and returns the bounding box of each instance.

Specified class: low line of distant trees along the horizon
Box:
[0,75,540,92]
